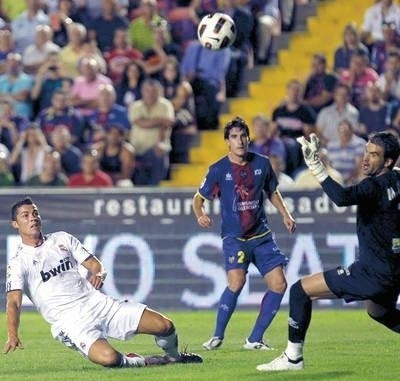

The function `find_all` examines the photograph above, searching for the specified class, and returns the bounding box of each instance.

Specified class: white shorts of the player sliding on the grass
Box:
[51,292,147,357]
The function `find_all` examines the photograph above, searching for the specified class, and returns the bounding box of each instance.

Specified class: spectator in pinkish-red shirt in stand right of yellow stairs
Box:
[340,49,379,108]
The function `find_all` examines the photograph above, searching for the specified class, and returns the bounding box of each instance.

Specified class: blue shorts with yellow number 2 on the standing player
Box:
[222,232,288,276]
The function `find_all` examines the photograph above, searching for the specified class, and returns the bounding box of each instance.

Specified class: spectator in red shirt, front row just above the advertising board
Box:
[68,149,113,188]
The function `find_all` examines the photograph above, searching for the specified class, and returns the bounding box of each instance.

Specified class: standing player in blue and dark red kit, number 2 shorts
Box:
[193,117,296,350]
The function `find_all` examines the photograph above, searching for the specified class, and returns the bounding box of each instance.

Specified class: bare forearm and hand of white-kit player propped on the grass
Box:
[3,290,24,354]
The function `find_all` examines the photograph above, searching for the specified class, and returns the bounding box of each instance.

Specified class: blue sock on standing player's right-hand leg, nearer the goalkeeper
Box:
[248,291,283,343]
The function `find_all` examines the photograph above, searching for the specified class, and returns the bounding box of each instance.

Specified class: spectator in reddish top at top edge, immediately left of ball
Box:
[167,0,201,50]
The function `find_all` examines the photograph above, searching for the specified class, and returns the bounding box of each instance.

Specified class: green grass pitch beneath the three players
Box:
[0,308,400,381]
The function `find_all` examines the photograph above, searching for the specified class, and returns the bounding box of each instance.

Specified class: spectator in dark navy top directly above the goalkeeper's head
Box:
[357,83,392,137]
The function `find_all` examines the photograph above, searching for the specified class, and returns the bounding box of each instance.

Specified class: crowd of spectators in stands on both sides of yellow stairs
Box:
[0,0,400,188]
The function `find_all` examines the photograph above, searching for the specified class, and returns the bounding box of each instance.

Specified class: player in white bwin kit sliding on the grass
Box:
[3,197,202,367]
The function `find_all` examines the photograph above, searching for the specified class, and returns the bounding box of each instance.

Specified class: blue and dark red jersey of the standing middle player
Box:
[198,152,278,239]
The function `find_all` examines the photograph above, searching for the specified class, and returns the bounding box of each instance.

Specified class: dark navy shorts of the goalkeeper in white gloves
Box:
[324,262,400,307]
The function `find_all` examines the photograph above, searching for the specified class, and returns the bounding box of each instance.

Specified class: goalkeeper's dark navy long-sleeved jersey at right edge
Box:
[322,170,400,282]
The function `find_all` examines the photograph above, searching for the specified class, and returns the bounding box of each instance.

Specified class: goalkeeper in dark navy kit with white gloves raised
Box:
[257,132,400,372]
